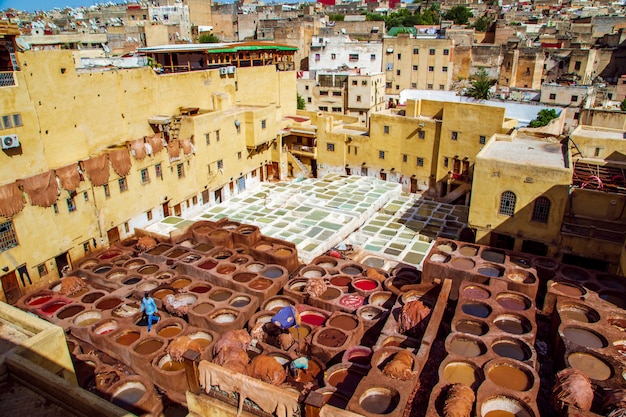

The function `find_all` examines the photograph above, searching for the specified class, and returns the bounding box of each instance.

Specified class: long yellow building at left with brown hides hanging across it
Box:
[0,29,296,301]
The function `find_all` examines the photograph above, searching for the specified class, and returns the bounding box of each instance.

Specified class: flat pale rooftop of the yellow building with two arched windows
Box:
[478,135,567,168]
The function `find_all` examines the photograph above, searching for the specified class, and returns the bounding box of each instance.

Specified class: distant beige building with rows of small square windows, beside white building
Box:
[383,33,454,95]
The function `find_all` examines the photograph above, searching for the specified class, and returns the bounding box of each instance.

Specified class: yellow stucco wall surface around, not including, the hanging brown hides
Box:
[0,51,296,292]
